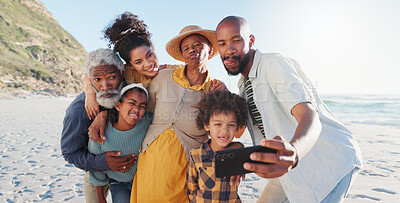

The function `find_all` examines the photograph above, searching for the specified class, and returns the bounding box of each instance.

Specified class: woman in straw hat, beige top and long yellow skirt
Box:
[131,25,225,202]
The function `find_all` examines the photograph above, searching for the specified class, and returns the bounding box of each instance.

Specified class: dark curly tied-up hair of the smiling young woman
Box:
[103,12,153,63]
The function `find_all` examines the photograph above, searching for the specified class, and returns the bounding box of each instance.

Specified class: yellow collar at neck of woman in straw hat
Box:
[172,66,211,93]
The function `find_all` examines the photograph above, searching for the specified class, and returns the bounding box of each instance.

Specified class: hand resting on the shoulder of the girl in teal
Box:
[89,111,108,144]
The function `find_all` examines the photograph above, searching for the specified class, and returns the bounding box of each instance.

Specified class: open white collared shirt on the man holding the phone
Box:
[238,50,362,203]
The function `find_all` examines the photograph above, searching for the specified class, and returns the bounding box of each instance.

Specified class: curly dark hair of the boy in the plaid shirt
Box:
[194,90,248,129]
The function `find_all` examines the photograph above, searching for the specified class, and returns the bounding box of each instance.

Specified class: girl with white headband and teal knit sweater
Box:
[88,83,153,203]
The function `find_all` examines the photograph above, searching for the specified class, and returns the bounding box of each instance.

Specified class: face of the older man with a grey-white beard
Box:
[89,65,122,109]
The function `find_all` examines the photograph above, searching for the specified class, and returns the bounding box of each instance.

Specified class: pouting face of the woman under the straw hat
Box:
[181,34,212,66]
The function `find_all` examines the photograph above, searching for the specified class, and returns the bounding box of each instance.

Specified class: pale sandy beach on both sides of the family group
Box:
[0,98,400,202]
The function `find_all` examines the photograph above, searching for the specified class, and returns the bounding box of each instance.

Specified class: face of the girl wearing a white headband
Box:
[114,90,147,131]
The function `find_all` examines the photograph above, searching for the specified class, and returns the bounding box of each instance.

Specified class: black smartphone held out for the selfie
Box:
[215,146,276,178]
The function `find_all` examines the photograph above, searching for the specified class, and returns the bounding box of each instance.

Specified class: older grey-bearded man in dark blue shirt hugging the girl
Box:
[61,49,135,202]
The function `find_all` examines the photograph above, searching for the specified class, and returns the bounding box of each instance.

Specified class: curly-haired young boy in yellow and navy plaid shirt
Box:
[187,90,247,202]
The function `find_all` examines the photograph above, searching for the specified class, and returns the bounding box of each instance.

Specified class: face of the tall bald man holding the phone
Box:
[216,21,255,75]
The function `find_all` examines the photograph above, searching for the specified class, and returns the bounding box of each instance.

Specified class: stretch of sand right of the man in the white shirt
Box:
[345,124,400,202]
